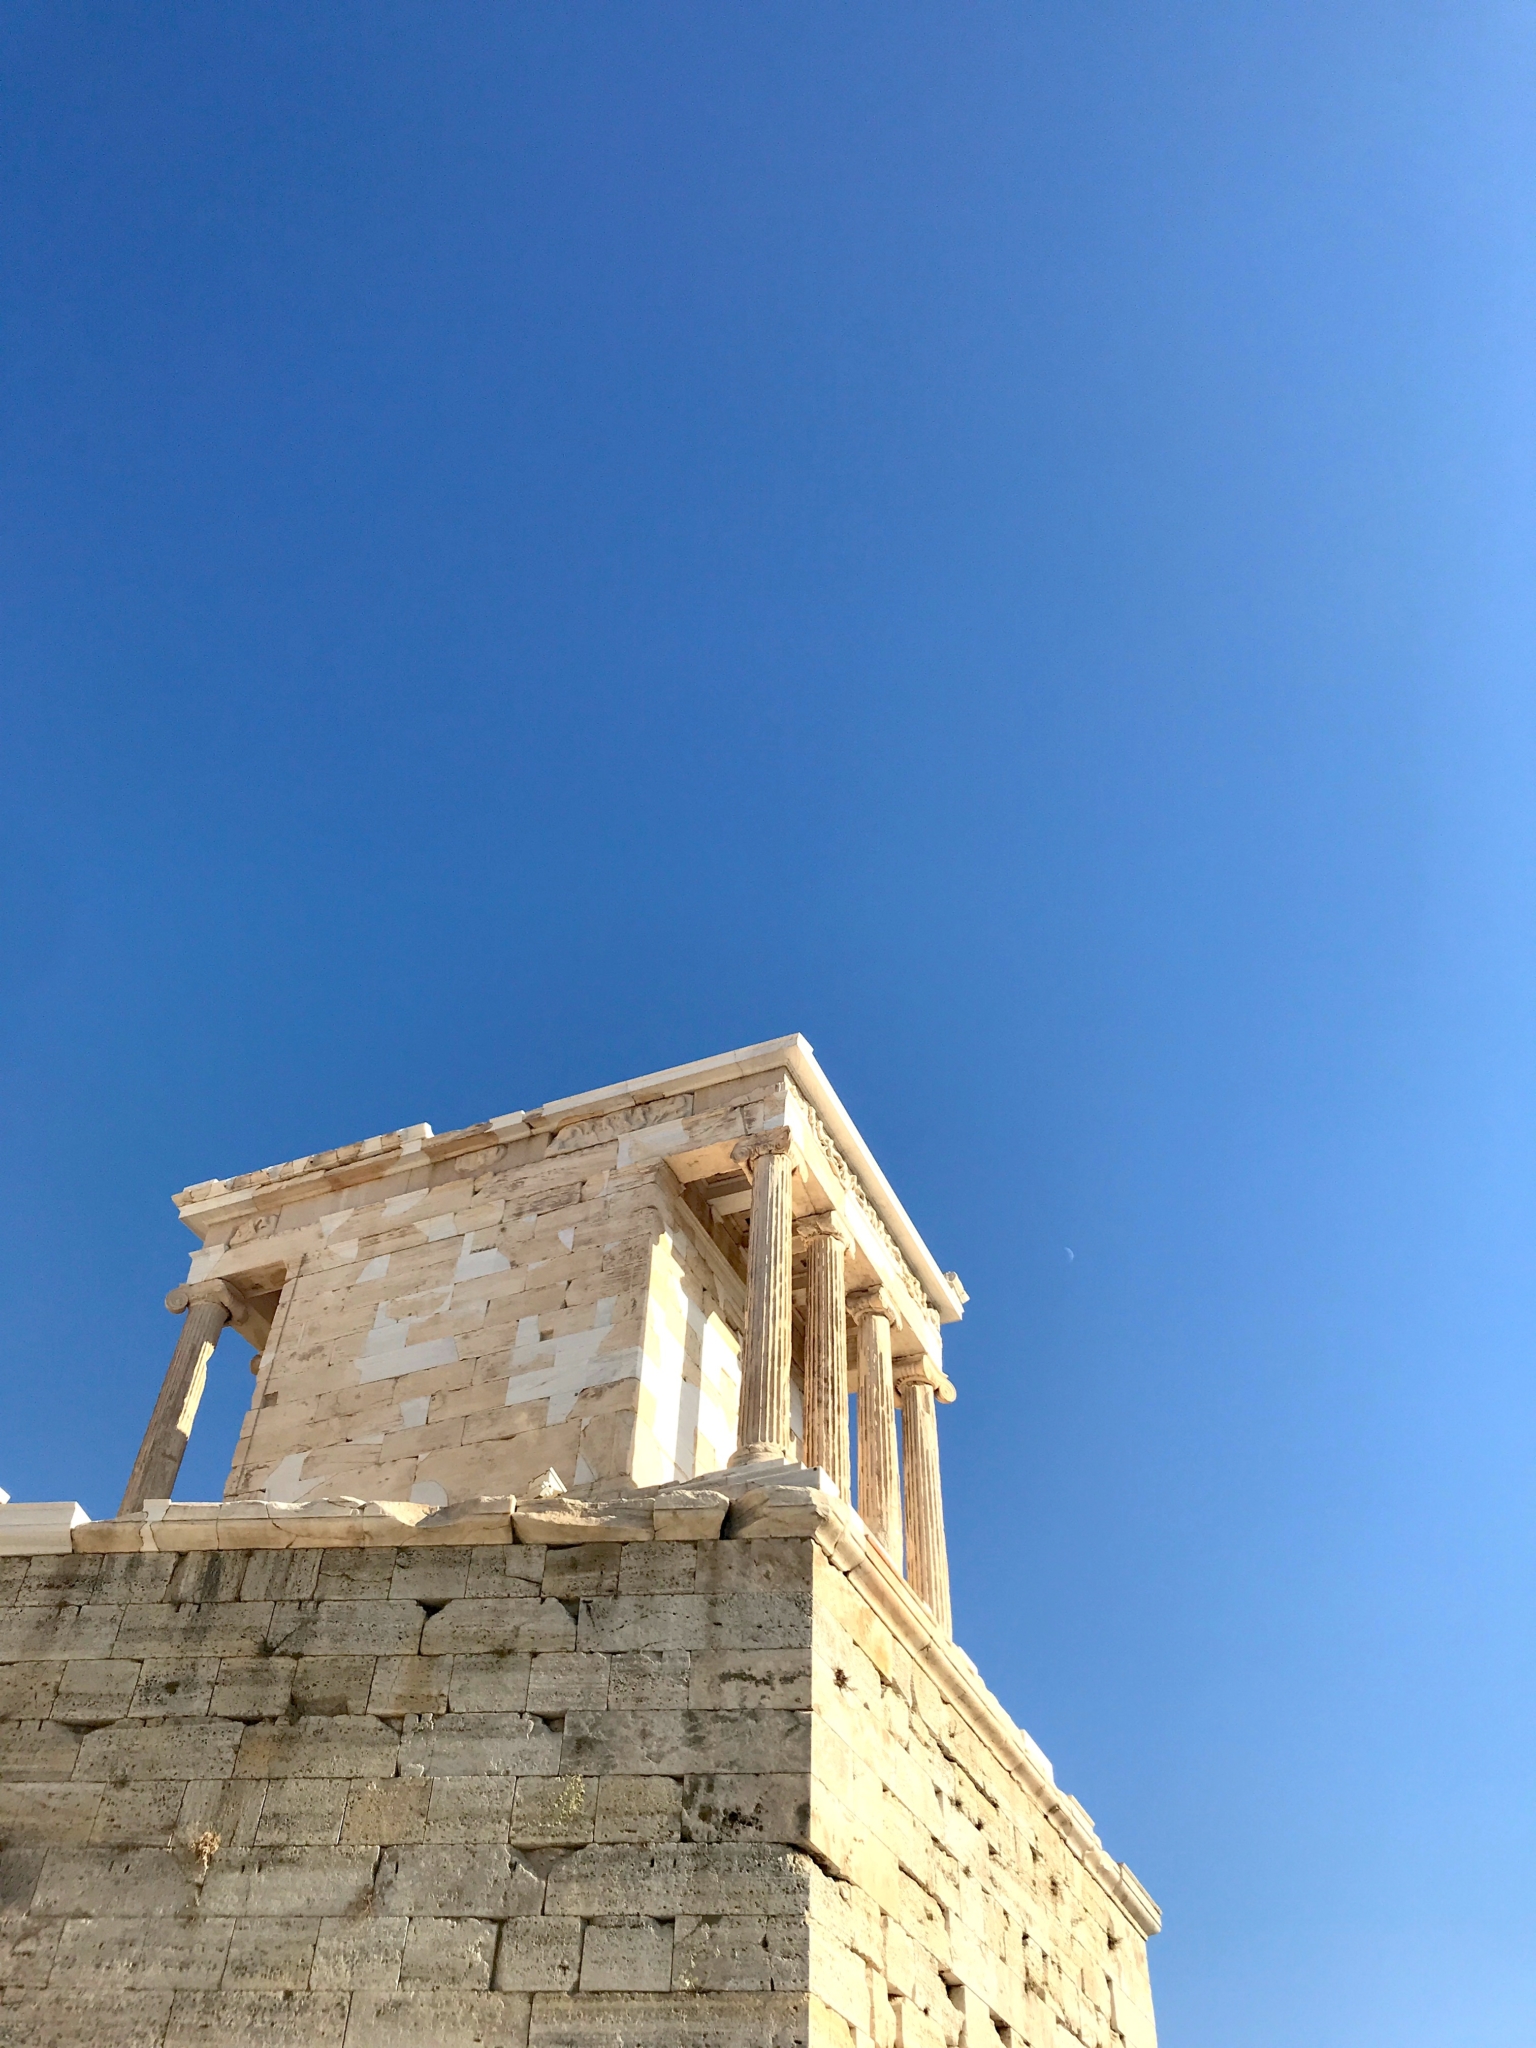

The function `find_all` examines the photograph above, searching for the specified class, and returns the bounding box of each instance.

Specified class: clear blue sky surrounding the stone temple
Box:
[0,0,1536,2048]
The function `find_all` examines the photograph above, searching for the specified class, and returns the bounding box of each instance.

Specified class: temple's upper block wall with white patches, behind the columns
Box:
[225,1147,741,1505]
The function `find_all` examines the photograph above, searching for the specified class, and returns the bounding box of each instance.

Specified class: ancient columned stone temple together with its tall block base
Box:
[0,1038,1159,2048]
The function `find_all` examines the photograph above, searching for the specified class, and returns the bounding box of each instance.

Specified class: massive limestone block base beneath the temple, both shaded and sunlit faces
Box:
[0,1509,1153,2048]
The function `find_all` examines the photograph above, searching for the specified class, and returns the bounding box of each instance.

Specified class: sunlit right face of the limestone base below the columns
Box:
[811,1550,1157,2048]
